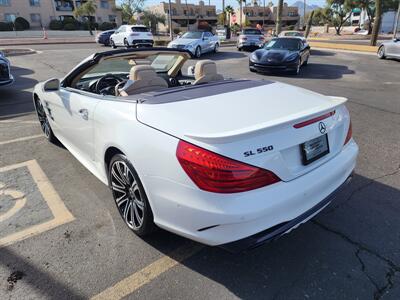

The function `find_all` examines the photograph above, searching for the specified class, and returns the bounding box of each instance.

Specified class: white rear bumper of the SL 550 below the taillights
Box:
[147,140,358,248]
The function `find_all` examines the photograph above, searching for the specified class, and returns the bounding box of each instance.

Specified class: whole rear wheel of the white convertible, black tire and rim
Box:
[108,154,156,236]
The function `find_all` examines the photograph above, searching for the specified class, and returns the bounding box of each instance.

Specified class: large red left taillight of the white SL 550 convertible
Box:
[176,141,281,193]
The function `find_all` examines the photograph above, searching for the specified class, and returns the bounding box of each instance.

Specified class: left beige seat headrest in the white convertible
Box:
[118,65,168,97]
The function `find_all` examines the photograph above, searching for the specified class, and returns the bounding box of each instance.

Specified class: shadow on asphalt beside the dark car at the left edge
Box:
[0,66,38,117]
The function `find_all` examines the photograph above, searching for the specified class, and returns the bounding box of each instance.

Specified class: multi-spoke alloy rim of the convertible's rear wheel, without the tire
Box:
[110,160,145,230]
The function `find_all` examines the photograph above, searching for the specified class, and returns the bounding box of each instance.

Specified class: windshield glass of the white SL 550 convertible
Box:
[82,54,179,79]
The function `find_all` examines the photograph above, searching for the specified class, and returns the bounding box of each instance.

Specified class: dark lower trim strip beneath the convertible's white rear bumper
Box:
[219,174,353,253]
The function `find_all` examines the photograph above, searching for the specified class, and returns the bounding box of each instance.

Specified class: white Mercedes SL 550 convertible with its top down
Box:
[33,48,358,251]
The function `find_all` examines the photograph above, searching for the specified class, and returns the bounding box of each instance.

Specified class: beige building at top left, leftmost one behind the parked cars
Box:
[0,0,121,28]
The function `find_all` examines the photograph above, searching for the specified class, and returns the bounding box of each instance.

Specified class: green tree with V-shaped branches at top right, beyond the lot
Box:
[326,0,355,35]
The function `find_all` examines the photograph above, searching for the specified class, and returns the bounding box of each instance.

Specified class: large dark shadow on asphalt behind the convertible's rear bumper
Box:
[142,175,400,299]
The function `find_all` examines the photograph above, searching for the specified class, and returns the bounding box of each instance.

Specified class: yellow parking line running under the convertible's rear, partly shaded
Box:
[91,243,204,300]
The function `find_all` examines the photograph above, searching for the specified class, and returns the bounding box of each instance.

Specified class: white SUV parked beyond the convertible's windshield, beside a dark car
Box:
[110,25,154,48]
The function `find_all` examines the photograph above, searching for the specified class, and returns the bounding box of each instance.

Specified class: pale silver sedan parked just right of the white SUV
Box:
[168,31,220,58]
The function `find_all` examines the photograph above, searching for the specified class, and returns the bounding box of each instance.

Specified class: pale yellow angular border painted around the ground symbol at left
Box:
[0,160,75,248]
